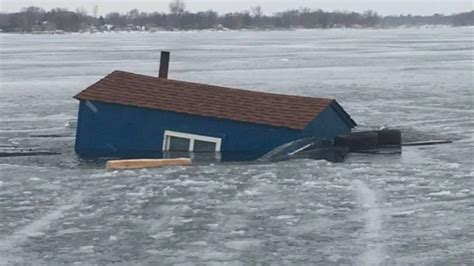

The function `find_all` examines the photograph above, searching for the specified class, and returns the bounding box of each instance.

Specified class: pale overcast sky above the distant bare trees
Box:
[0,0,473,15]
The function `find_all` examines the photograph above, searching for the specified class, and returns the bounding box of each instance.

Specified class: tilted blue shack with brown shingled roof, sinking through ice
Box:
[75,52,356,159]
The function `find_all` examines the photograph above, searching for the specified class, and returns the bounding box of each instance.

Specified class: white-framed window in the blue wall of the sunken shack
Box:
[163,130,222,152]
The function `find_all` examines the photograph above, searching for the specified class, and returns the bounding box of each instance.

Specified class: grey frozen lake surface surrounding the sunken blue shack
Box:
[0,28,474,265]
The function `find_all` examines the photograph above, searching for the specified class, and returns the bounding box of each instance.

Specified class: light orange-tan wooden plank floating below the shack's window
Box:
[106,158,191,170]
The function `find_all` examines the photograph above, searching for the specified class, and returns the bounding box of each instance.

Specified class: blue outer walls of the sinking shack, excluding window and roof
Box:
[75,101,350,160]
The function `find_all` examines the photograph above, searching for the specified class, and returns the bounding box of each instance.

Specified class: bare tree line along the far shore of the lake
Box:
[0,0,474,32]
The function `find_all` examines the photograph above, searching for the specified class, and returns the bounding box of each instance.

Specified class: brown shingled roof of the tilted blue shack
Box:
[75,71,333,130]
